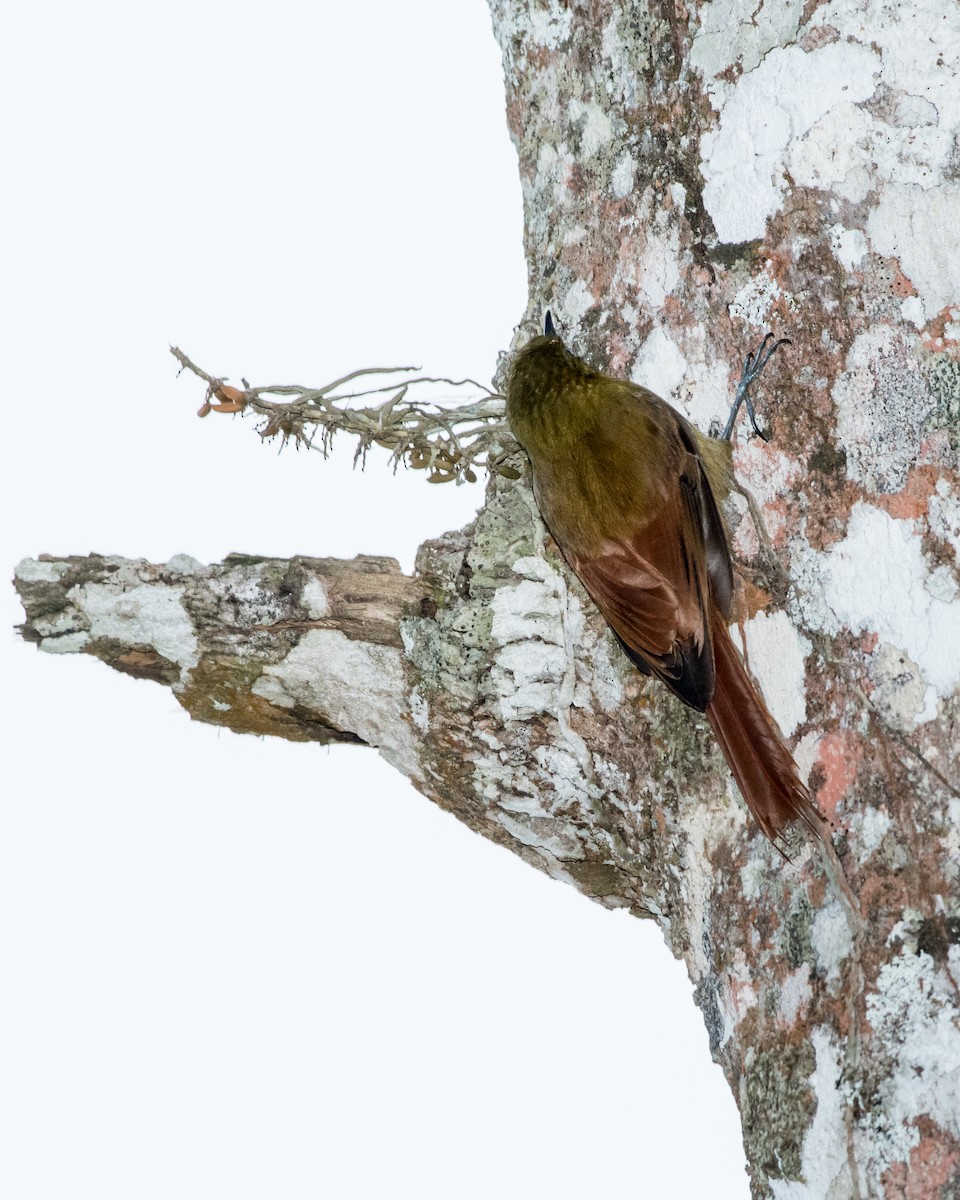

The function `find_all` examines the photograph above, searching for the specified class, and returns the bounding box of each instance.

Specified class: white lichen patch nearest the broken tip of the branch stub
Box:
[68,580,199,689]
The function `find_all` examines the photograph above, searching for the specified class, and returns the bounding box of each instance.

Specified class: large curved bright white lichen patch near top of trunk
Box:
[701,43,880,242]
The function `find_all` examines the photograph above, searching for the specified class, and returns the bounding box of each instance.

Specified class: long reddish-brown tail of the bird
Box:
[707,612,827,853]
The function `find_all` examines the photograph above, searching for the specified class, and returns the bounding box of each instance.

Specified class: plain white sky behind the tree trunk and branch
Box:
[0,0,748,1200]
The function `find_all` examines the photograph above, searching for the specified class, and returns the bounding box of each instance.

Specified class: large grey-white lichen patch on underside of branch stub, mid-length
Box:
[251,629,421,779]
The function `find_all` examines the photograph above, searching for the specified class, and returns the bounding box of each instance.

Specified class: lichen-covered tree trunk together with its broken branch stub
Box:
[18,0,960,1200]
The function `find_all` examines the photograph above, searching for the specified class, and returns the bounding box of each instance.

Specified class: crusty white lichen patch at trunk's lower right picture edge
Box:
[860,947,960,1186]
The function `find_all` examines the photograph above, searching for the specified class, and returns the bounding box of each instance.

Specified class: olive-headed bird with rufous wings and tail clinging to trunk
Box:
[506,312,823,857]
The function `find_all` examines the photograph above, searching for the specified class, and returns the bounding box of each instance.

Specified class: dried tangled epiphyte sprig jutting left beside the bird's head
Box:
[170,346,520,484]
